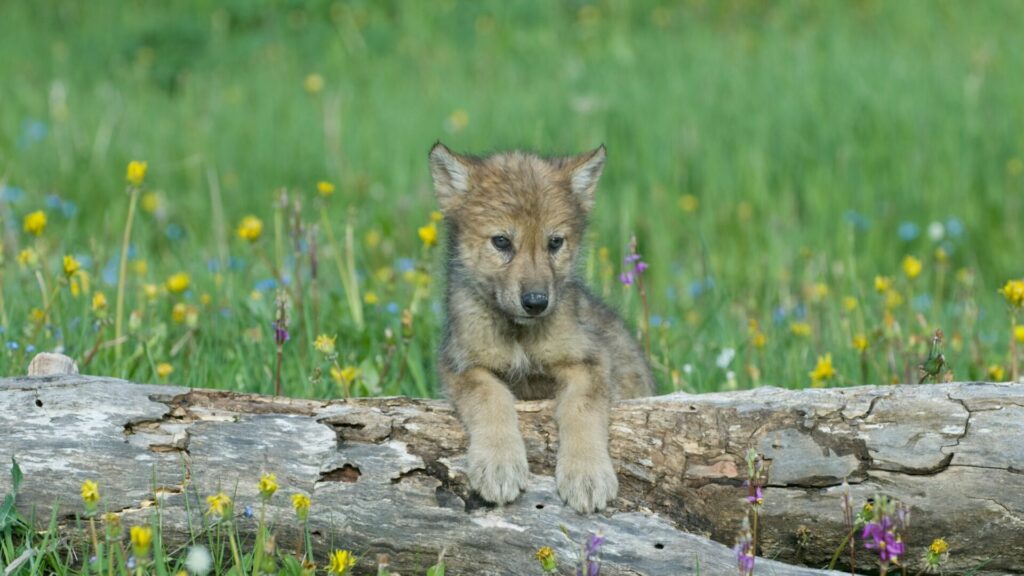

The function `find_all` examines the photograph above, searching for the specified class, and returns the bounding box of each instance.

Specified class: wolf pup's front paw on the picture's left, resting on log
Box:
[468,436,529,504]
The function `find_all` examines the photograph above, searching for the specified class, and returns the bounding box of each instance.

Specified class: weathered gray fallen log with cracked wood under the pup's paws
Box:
[0,375,1024,576]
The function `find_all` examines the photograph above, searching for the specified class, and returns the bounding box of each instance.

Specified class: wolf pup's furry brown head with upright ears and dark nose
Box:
[430,142,605,324]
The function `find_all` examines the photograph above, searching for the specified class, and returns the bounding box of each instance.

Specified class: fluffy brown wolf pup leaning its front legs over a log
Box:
[430,142,654,512]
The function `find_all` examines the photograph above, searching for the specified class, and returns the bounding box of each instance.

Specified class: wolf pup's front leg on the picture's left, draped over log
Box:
[442,368,529,504]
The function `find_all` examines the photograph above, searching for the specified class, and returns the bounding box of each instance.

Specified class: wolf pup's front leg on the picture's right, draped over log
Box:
[553,363,618,513]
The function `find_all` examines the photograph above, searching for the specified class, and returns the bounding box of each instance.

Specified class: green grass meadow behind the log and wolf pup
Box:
[0,0,1024,397]
